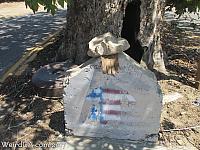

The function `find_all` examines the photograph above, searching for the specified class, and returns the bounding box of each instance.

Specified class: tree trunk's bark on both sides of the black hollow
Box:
[60,0,165,71]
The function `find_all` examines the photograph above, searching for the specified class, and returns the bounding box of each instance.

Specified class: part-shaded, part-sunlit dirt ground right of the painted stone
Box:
[159,24,200,149]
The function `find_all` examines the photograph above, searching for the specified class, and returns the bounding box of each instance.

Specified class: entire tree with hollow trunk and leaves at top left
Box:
[25,0,165,72]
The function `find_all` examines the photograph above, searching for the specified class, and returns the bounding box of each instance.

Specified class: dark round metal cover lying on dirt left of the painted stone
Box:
[32,62,71,98]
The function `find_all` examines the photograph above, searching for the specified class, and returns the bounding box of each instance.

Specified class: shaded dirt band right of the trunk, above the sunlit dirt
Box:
[160,23,200,87]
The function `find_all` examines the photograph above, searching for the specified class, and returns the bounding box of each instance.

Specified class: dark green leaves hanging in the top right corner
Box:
[167,0,200,15]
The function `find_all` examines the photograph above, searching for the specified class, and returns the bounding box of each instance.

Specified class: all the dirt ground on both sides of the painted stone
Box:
[0,4,200,149]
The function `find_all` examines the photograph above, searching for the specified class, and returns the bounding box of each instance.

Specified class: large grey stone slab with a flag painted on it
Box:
[64,53,162,141]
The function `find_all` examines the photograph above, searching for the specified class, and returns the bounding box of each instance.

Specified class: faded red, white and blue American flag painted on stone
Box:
[86,87,135,124]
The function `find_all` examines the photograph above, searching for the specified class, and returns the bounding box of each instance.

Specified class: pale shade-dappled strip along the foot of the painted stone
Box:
[56,137,155,150]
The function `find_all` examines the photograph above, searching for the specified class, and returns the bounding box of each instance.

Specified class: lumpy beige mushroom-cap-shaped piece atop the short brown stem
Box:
[87,32,130,57]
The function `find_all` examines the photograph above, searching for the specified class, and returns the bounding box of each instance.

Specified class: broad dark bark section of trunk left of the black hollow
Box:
[61,0,127,64]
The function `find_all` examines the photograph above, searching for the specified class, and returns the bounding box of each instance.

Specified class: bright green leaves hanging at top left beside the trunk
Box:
[25,0,69,15]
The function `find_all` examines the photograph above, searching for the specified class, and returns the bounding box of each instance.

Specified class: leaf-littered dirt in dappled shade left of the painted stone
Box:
[0,35,64,149]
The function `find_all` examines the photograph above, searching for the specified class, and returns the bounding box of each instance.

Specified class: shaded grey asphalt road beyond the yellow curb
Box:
[0,10,66,75]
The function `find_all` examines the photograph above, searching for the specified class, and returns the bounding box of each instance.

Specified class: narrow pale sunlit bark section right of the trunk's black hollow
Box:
[139,0,167,73]
